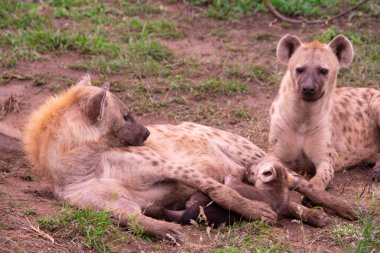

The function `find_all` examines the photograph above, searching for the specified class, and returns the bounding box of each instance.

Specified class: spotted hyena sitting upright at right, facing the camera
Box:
[269,35,380,189]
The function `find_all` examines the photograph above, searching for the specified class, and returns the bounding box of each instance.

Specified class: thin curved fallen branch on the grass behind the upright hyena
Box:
[265,0,368,25]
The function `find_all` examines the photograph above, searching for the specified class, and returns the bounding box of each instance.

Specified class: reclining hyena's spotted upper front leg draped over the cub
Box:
[164,166,277,224]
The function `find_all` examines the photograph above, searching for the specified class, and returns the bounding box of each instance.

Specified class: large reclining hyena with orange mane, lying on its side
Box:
[23,76,277,240]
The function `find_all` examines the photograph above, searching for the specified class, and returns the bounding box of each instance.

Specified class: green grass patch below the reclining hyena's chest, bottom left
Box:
[37,206,127,252]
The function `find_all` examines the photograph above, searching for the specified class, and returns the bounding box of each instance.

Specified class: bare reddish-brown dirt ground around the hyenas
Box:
[0,0,380,252]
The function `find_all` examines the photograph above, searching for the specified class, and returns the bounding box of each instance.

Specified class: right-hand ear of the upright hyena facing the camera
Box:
[329,35,354,67]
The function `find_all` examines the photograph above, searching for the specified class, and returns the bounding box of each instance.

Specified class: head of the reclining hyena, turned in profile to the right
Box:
[77,76,150,147]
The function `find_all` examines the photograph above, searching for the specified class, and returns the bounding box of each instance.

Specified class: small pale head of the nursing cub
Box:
[246,157,287,187]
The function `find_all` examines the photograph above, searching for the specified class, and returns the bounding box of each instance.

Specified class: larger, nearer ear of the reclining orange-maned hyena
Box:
[86,83,110,123]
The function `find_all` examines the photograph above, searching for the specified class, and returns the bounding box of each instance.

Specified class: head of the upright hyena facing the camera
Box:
[277,35,354,102]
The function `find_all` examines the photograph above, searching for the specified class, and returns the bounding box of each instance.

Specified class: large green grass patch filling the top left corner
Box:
[0,0,184,78]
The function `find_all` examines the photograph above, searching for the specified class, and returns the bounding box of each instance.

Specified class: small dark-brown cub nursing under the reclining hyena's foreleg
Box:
[146,157,332,227]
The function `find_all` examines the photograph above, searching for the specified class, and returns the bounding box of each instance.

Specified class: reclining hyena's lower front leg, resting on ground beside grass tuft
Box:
[64,179,184,242]
